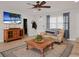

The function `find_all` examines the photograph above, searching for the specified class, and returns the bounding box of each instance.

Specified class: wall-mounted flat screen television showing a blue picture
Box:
[3,12,21,23]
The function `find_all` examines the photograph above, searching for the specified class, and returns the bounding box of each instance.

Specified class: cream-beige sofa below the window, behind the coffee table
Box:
[40,29,64,43]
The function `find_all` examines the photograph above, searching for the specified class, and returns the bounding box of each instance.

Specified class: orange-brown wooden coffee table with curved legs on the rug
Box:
[25,39,54,56]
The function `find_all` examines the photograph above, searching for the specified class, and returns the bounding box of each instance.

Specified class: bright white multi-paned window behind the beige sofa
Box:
[49,16,63,29]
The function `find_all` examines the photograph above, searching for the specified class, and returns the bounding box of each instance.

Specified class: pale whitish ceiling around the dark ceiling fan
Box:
[0,1,79,13]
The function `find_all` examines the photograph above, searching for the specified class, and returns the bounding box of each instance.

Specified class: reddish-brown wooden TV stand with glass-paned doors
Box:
[4,28,23,42]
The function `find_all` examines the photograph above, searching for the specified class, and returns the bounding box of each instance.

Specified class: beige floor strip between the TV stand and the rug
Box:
[0,36,31,52]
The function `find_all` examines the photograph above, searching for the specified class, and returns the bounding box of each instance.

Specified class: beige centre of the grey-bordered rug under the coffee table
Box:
[1,44,72,57]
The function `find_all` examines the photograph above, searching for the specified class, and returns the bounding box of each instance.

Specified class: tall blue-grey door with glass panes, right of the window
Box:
[63,12,70,39]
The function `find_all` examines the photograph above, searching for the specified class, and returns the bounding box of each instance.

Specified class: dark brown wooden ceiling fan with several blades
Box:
[27,1,51,11]
